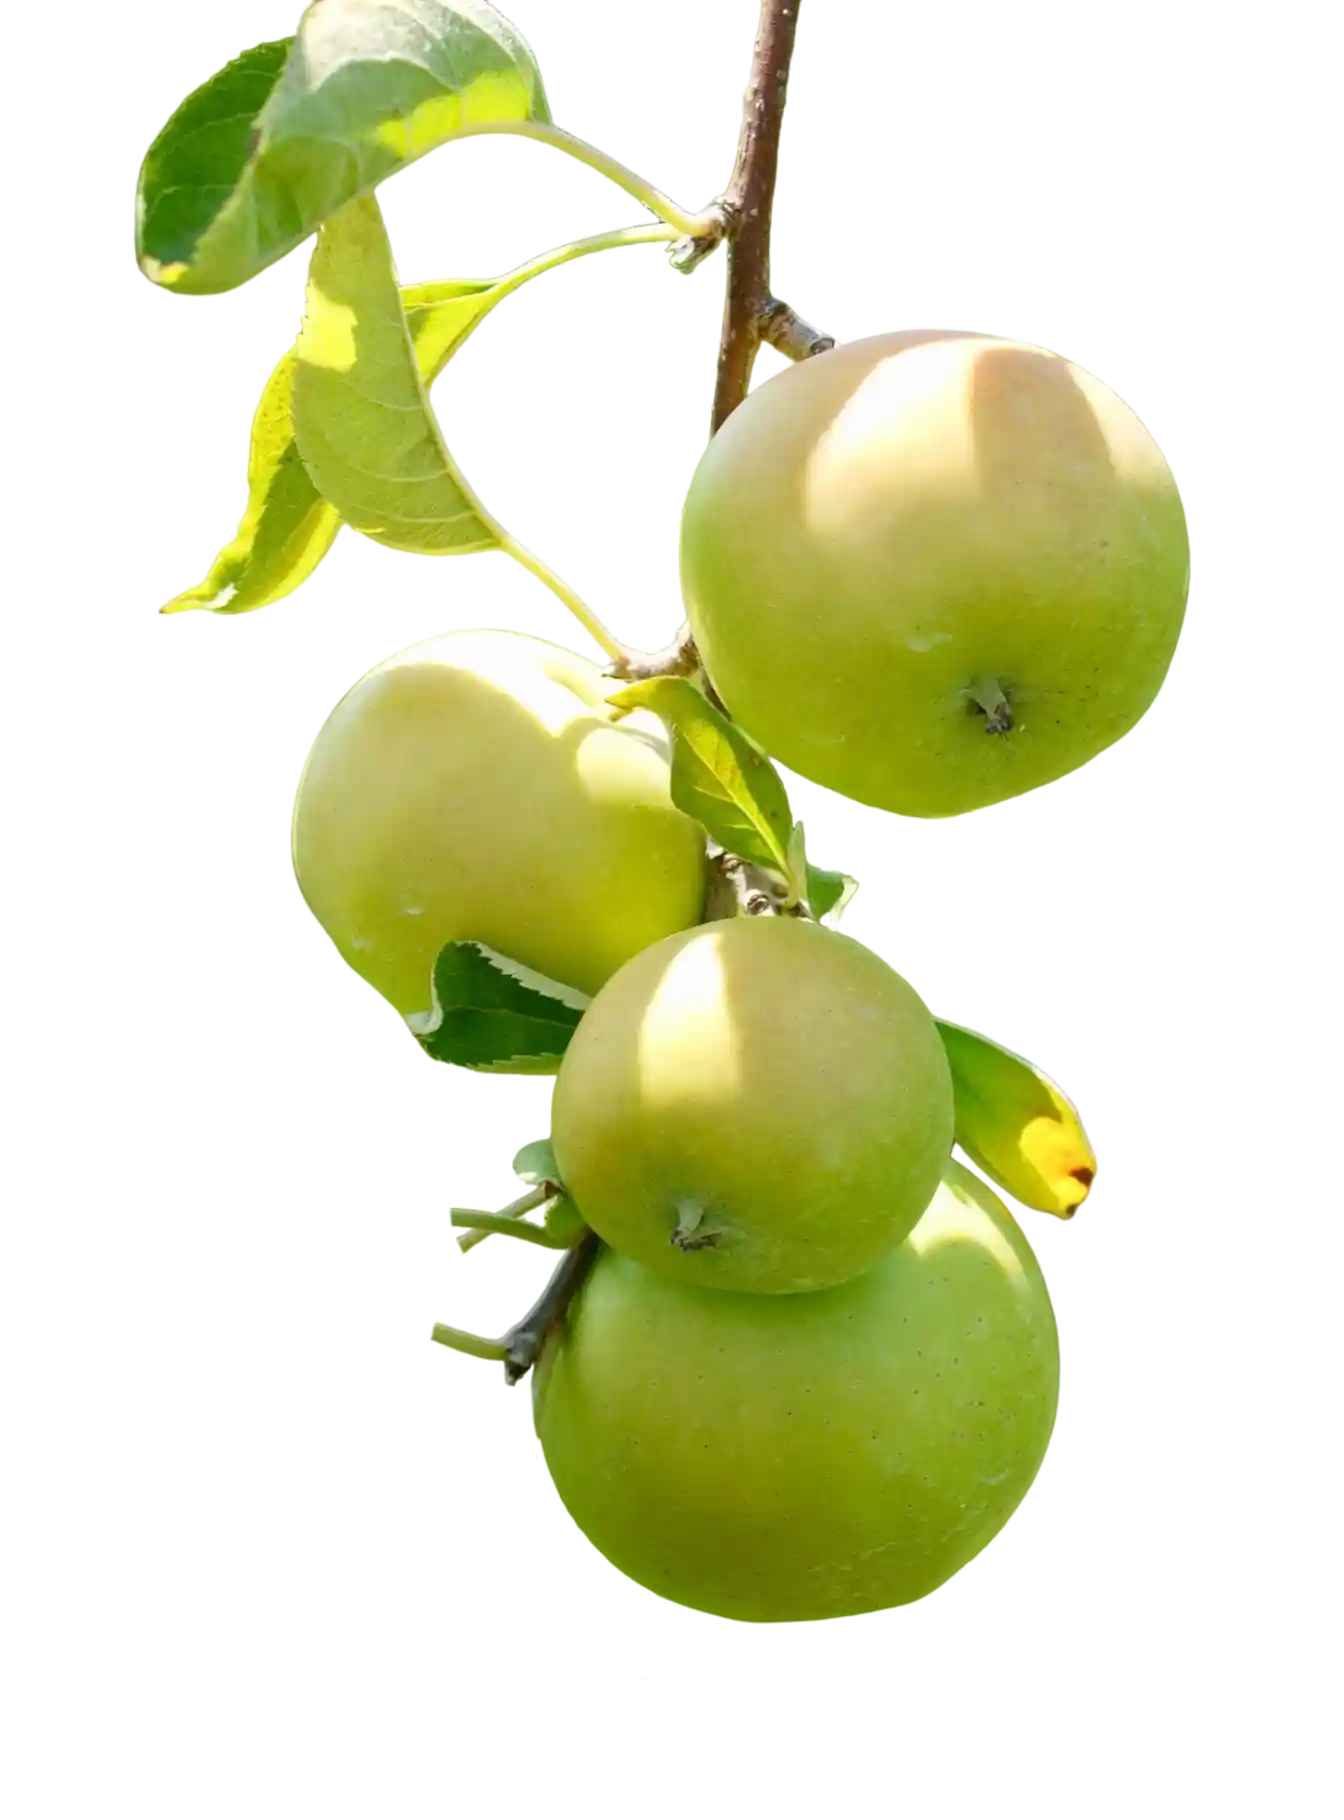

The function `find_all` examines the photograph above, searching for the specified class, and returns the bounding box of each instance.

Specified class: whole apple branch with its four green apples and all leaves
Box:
[131,0,1191,1627]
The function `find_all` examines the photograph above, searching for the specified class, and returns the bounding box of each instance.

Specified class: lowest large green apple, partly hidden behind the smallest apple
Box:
[530,1165,1062,1625]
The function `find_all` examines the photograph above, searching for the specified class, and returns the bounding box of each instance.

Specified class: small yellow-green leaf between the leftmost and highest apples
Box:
[608,677,794,879]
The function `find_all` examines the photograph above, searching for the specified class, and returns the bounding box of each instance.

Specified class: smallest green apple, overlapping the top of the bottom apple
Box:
[550,917,952,1294]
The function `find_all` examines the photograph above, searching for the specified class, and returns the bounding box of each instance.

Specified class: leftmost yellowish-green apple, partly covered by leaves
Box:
[291,632,707,1017]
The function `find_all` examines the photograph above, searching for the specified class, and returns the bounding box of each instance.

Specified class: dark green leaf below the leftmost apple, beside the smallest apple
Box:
[408,941,586,1077]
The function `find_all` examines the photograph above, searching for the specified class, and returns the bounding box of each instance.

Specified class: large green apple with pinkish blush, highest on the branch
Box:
[679,333,1191,819]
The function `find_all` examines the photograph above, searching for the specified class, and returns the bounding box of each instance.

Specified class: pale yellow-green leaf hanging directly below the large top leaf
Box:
[293,197,497,557]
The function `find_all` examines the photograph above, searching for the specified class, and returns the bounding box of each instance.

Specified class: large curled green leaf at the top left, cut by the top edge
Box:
[133,0,550,297]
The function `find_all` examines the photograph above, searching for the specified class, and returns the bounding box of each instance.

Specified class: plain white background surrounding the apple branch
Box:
[0,0,1344,1820]
